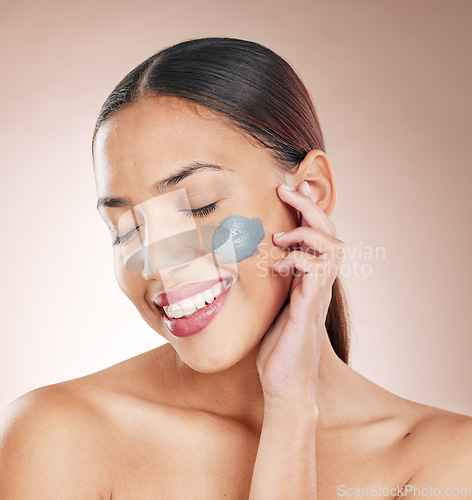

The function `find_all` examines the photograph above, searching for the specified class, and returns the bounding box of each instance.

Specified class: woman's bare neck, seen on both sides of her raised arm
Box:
[172,329,396,430]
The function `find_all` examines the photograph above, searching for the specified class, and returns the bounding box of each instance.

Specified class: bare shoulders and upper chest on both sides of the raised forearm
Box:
[0,344,471,500]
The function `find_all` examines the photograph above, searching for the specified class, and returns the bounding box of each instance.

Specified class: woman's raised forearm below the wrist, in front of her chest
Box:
[249,403,318,500]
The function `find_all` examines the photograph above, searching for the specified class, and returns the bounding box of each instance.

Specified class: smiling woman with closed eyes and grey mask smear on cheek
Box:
[0,38,472,500]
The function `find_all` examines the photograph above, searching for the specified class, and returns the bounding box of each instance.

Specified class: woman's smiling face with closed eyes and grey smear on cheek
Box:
[94,96,298,373]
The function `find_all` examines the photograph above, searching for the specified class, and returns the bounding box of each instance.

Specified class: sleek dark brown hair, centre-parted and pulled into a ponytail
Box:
[92,37,350,364]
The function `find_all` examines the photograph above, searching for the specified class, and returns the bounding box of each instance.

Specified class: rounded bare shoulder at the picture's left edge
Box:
[0,383,113,500]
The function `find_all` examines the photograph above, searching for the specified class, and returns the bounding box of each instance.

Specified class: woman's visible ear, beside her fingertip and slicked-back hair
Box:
[296,149,336,217]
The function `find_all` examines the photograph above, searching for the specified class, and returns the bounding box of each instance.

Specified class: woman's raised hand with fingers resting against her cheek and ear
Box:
[257,182,344,404]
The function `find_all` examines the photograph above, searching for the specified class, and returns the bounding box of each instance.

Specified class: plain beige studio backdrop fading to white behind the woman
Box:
[0,0,472,415]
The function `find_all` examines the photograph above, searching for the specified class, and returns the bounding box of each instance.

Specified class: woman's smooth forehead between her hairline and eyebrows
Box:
[94,96,254,180]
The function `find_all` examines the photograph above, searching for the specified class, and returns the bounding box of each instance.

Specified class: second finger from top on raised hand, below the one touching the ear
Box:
[272,226,345,259]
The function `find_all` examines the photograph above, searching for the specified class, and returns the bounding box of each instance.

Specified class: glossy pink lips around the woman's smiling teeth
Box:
[158,277,234,337]
